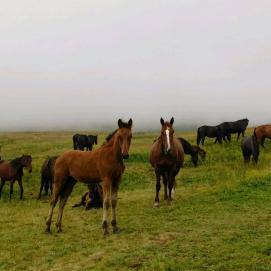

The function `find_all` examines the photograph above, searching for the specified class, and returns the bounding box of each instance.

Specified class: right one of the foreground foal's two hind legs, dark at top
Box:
[56,178,76,233]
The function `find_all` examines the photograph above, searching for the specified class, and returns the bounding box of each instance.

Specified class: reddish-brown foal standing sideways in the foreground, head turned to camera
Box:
[46,119,133,234]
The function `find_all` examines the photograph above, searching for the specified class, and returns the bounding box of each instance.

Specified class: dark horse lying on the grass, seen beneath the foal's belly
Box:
[72,183,103,210]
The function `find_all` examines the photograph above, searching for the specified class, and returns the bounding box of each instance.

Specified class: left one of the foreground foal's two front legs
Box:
[102,177,111,235]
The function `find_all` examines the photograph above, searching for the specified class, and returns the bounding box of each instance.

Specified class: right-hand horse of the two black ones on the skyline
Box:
[215,119,249,142]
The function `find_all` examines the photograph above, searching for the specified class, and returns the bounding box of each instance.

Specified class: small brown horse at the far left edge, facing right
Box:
[0,155,32,199]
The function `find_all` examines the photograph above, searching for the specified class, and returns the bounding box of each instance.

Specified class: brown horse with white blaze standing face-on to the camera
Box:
[150,118,184,207]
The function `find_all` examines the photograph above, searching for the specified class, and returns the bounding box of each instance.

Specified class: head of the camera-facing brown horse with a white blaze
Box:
[160,117,174,154]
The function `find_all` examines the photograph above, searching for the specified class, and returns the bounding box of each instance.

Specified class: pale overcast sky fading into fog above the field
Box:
[0,0,271,131]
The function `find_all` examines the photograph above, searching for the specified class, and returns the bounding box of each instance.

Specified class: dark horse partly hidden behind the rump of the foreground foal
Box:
[38,156,57,199]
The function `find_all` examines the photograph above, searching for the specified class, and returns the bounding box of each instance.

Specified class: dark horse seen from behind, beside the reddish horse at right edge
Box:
[241,134,260,164]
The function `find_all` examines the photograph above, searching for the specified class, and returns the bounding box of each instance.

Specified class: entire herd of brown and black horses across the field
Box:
[0,118,271,235]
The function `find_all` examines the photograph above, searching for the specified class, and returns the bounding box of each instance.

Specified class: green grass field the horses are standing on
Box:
[0,130,271,271]
